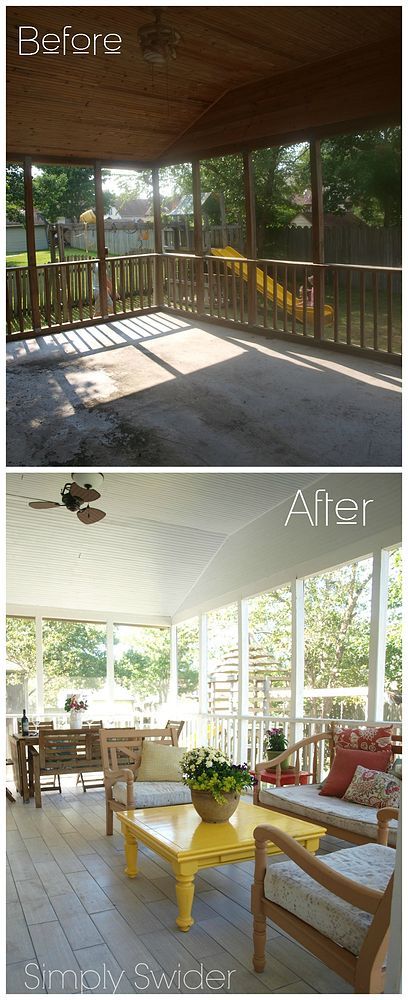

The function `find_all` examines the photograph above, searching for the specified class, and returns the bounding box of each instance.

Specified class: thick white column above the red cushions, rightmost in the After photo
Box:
[367,549,390,722]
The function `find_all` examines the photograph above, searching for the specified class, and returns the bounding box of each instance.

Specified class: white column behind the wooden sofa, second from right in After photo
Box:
[289,580,305,743]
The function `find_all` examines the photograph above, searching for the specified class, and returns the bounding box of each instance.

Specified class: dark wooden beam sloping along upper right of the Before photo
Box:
[160,38,401,165]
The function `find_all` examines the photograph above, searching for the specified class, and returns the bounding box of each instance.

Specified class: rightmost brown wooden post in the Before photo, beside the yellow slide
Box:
[310,139,324,340]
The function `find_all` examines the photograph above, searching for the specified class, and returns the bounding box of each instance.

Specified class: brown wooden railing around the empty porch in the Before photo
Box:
[6,253,401,360]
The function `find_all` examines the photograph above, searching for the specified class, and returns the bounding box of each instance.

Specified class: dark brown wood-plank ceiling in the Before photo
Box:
[7,6,401,165]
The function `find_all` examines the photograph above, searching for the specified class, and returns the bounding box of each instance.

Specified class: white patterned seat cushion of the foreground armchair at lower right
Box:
[264,844,395,955]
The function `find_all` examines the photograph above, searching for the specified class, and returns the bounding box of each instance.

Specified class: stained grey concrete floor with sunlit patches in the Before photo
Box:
[7,312,401,467]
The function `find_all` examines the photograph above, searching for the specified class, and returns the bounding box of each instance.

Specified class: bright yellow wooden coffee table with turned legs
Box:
[117,801,326,931]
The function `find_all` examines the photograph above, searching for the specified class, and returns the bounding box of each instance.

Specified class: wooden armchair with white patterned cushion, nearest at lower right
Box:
[251,808,398,993]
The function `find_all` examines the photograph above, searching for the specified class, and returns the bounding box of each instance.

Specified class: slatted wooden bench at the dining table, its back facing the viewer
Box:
[28,729,102,809]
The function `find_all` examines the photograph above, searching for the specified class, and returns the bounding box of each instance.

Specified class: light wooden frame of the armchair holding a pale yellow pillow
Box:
[100,723,180,836]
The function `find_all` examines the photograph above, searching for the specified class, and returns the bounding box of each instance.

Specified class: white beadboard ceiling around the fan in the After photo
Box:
[7,471,320,619]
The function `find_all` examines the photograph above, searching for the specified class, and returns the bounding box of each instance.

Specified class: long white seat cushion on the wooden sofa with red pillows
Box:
[259,785,397,846]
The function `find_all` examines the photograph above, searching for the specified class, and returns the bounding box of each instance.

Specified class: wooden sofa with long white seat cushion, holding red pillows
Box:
[255,725,402,847]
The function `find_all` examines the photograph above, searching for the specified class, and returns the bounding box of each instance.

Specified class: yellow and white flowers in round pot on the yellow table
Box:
[181,747,254,823]
